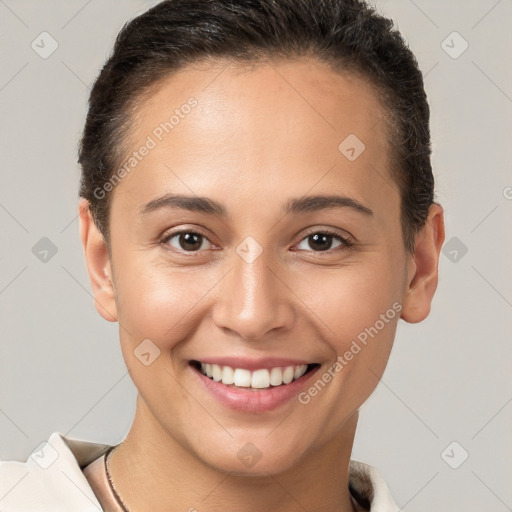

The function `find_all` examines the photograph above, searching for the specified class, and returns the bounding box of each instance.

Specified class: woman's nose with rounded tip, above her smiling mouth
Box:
[213,243,294,340]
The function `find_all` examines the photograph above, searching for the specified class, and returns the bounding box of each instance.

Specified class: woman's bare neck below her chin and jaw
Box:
[110,395,357,512]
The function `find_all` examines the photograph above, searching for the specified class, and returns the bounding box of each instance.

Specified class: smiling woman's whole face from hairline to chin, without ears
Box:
[94,59,414,474]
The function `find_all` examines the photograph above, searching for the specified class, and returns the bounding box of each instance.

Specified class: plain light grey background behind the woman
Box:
[0,0,512,512]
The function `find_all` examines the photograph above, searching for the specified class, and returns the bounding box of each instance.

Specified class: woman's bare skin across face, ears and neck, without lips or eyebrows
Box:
[79,58,444,512]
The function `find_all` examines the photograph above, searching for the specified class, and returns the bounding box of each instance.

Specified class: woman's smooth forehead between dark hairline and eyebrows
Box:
[114,58,397,221]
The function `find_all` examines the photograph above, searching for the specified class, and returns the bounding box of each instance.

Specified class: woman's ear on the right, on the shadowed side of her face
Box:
[401,203,444,323]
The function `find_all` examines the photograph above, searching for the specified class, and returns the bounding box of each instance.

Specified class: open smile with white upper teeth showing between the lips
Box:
[190,360,320,390]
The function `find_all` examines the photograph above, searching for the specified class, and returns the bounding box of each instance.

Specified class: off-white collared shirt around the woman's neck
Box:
[0,432,399,512]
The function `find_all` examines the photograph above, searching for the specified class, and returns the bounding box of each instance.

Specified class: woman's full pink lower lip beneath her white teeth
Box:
[191,366,320,413]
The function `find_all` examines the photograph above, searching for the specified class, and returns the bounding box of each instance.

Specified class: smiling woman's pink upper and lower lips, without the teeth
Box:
[189,358,320,413]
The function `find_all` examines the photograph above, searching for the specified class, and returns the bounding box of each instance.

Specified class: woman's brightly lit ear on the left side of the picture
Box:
[78,197,118,322]
